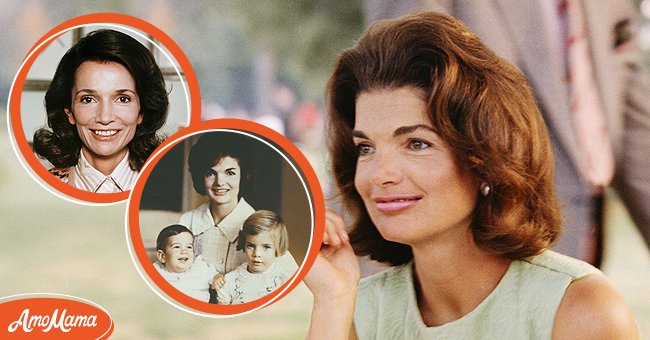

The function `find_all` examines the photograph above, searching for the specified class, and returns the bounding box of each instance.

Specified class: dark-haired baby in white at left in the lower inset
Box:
[154,224,222,302]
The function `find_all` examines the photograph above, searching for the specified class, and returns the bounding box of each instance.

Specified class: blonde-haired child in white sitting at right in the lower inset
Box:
[217,210,298,304]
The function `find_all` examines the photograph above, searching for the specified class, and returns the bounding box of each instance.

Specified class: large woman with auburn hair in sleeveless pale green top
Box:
[305,13,639,339]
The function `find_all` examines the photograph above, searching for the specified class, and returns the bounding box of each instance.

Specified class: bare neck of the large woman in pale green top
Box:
[413,230,512,327]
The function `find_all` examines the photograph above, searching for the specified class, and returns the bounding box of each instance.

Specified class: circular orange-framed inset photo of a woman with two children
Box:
[127,119,324,316]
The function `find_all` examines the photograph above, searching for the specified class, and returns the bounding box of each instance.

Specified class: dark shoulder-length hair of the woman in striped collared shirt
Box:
[33,29,169,171]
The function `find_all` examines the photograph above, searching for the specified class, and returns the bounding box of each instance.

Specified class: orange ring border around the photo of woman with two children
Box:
[126,118,325,316]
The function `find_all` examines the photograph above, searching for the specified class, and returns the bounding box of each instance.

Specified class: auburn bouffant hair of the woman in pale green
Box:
[327,13,561,265]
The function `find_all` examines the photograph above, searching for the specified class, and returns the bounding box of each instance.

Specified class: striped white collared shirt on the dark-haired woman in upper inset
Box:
[68,151,138,193]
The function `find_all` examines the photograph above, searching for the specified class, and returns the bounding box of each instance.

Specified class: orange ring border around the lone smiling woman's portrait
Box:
[9,13,201,203]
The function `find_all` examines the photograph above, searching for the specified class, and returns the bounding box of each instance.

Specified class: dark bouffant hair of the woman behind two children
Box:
[187,131,255,198]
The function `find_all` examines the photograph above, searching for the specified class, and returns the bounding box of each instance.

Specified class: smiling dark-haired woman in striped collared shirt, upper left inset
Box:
[34,29,169,193]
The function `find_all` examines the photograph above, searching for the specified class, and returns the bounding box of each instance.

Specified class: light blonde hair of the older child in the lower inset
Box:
[237,210,289,257]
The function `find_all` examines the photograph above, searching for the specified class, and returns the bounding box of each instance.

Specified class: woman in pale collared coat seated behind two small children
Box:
[178,131,298,294]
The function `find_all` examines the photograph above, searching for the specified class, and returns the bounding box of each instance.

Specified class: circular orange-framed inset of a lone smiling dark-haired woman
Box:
[9,14,198,203]
